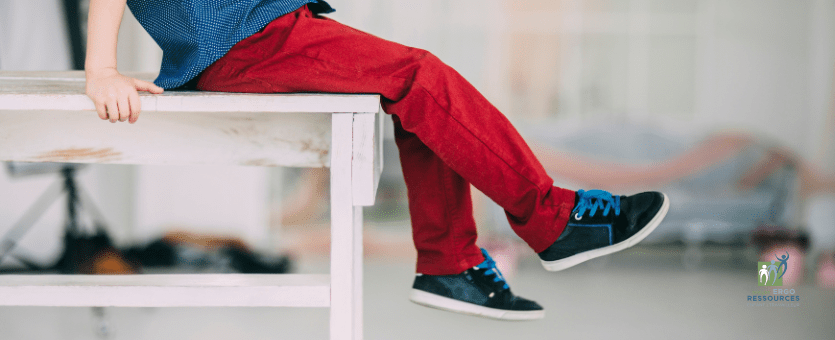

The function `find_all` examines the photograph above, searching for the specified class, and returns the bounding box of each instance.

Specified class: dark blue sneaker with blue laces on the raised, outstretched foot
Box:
[539,190,670,271]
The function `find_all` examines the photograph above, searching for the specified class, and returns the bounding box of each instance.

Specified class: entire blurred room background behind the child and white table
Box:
[0,0,835,339]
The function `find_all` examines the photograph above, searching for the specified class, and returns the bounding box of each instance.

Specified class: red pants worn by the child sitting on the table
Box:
[197,6,574,275]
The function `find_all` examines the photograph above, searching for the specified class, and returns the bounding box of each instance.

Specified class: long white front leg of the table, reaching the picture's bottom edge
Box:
[330,113,362,340]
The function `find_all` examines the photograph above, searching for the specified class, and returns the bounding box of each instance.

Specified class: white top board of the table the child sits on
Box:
[0,71,380,113]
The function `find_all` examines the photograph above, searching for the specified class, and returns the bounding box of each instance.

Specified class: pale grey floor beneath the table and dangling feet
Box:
[0,247,835,340]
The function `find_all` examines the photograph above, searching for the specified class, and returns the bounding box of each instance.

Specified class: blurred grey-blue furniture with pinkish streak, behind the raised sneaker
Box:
[506,121,799,269]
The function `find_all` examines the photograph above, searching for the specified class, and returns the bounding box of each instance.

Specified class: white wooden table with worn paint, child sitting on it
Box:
[0,72,382,339]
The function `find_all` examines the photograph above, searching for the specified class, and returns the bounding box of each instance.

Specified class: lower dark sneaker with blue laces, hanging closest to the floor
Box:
[409,249,545,320]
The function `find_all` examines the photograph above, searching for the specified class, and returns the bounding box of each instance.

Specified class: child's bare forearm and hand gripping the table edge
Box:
[84,0,163,123]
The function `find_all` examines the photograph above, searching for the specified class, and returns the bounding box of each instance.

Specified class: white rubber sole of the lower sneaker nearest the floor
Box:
[409,289,545,320]
